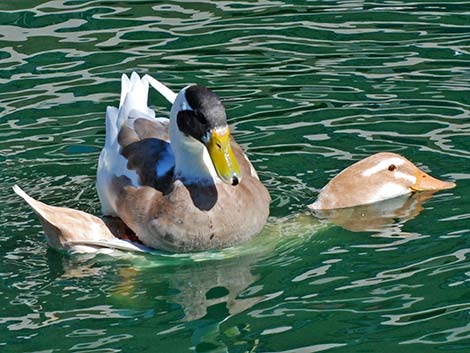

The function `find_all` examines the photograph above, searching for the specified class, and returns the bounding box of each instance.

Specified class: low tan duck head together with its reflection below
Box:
[308,152,455,232]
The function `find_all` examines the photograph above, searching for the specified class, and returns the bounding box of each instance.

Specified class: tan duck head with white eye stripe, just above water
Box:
[308,152,455,211]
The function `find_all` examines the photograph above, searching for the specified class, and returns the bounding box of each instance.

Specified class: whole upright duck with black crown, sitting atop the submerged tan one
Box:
[96,73,271,252]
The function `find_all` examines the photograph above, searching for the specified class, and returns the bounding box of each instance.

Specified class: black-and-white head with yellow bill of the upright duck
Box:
[170,85,241,185]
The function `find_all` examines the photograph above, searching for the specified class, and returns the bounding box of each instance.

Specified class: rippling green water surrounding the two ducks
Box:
[0,0,470,353]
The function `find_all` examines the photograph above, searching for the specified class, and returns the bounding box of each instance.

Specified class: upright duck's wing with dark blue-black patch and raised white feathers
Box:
[96,72,175,216]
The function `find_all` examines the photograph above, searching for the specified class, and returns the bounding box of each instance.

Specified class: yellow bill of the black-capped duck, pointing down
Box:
[206,127,241,185]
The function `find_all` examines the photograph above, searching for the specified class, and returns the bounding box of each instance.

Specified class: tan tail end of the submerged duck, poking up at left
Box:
[13,185,151,254]
